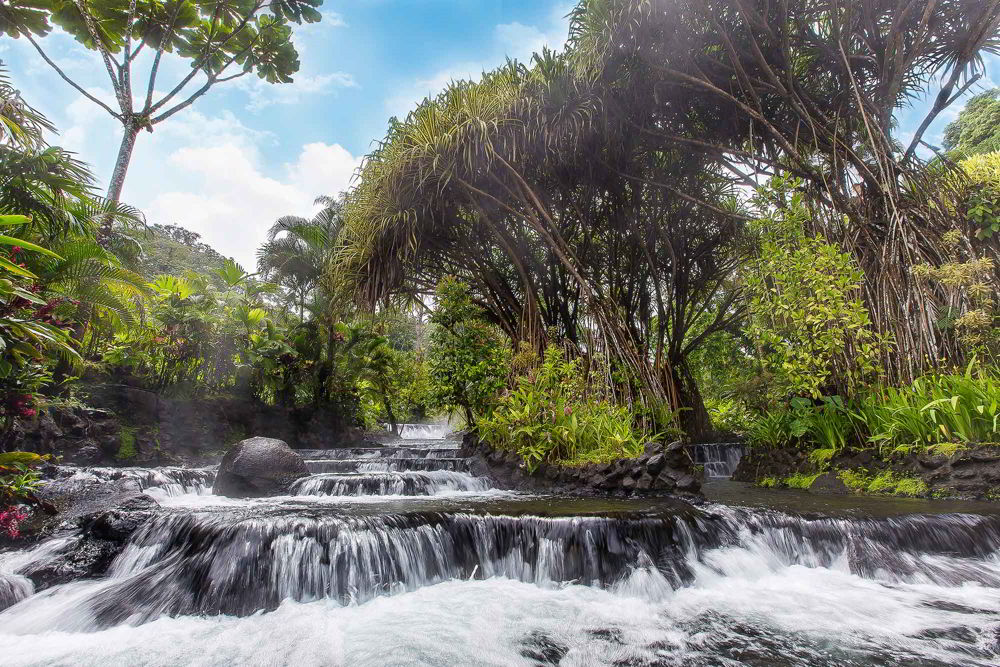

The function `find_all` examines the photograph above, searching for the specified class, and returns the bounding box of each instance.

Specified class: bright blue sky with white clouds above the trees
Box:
[0,0,1000,269]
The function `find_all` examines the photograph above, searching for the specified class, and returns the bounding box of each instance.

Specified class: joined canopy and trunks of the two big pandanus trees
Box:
[337,0,1000,438]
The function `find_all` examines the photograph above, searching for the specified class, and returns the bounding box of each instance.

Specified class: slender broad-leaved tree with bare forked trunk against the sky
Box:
[0,0,323,214]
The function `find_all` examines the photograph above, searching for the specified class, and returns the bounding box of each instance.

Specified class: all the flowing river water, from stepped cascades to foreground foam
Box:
[0,441,1000,667]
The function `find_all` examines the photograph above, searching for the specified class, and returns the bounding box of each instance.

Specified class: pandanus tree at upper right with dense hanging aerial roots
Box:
[569,0,1000,380]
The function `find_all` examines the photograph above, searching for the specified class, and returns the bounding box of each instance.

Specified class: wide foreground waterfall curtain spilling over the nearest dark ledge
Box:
[0,506,1000,633]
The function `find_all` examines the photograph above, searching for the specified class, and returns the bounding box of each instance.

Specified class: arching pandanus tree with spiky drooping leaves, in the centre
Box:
[337,52,741,432]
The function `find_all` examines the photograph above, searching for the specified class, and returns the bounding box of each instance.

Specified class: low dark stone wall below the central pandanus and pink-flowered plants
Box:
[459,433,701,496]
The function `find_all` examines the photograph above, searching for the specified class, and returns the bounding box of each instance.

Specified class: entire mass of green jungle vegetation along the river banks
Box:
[0,0,1000,486]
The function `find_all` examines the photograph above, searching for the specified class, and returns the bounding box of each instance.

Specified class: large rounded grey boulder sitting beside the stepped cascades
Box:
[214,436,309,498]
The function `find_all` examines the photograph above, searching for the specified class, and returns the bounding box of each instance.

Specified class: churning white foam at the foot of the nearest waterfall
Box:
[0,549,1000,667]
